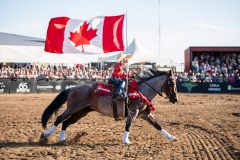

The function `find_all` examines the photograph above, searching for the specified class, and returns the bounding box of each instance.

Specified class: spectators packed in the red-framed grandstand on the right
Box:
[177,53,240,83]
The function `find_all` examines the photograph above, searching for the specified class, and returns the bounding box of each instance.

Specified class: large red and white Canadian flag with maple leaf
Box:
[45,15,124,54]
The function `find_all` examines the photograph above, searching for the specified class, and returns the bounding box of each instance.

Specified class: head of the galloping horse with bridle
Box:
[163,70,178,103]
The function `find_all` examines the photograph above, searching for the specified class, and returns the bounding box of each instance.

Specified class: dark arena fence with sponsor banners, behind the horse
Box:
[0,79,240,93]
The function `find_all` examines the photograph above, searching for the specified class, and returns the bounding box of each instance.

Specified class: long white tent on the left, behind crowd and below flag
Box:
[0,32,124,64]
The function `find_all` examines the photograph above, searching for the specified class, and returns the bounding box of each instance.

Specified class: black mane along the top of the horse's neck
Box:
[137,69,169,84]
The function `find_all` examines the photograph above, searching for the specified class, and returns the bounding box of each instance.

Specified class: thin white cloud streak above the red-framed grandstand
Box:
[188,21,240,34]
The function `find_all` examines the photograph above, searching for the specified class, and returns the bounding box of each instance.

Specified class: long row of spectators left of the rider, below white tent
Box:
[0,64,111,80]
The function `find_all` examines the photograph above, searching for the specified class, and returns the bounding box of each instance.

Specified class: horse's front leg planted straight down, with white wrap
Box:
[122,109,139,144]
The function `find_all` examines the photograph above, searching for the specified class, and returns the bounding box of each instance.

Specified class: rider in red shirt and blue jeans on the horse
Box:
[111,59,127,98]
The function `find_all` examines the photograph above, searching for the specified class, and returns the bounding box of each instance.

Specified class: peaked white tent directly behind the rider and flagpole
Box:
[99,39,157,64]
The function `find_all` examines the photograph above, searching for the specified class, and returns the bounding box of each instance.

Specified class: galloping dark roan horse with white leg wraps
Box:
[40,70,177,144]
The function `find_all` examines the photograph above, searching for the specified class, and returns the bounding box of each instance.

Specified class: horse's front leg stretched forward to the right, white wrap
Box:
[141,112,176,141]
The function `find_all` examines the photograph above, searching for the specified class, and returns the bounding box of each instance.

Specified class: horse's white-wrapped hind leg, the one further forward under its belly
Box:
[59,107,93,142]
